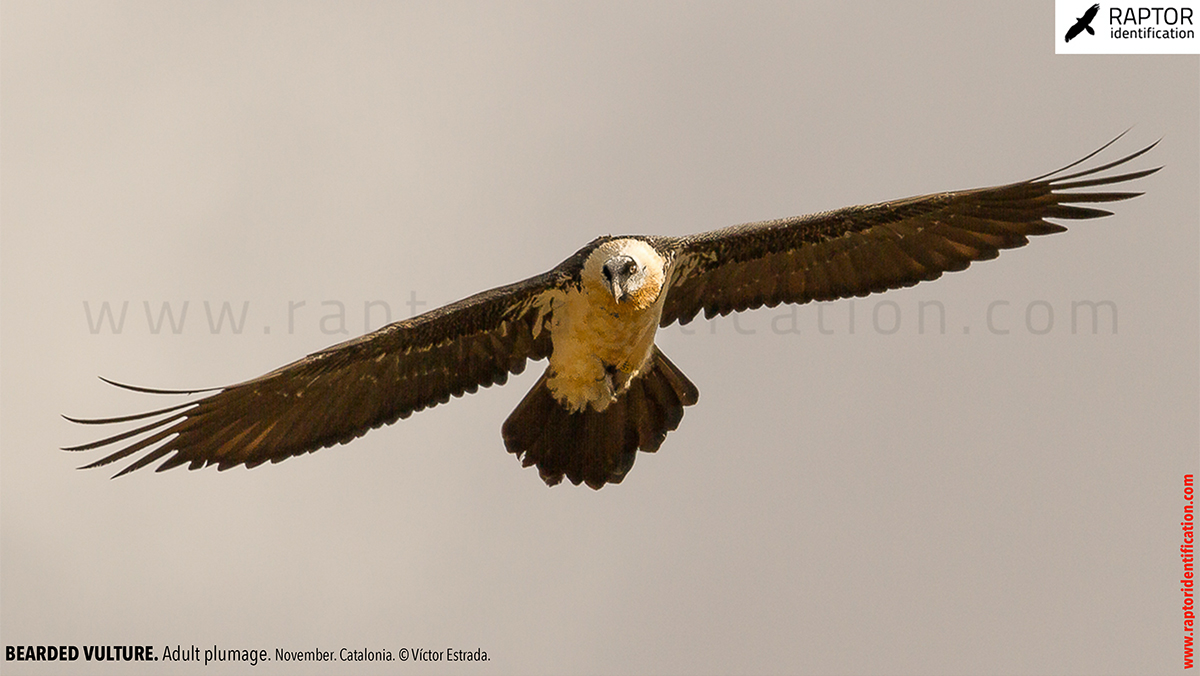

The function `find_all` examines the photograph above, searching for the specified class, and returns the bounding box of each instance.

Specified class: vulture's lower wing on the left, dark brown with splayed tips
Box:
[65,267,578,475]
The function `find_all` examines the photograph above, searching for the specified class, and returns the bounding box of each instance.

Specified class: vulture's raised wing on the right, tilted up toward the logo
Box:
[661,137,1160,327]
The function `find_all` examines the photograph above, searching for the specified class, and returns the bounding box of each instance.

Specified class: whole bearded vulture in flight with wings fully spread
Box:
[65,137,1160,489]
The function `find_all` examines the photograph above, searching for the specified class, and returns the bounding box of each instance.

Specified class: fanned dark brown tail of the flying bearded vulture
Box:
[502,347,700,489]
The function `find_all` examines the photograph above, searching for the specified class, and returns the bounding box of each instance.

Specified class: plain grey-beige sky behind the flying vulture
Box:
[0,1,1200,674]
